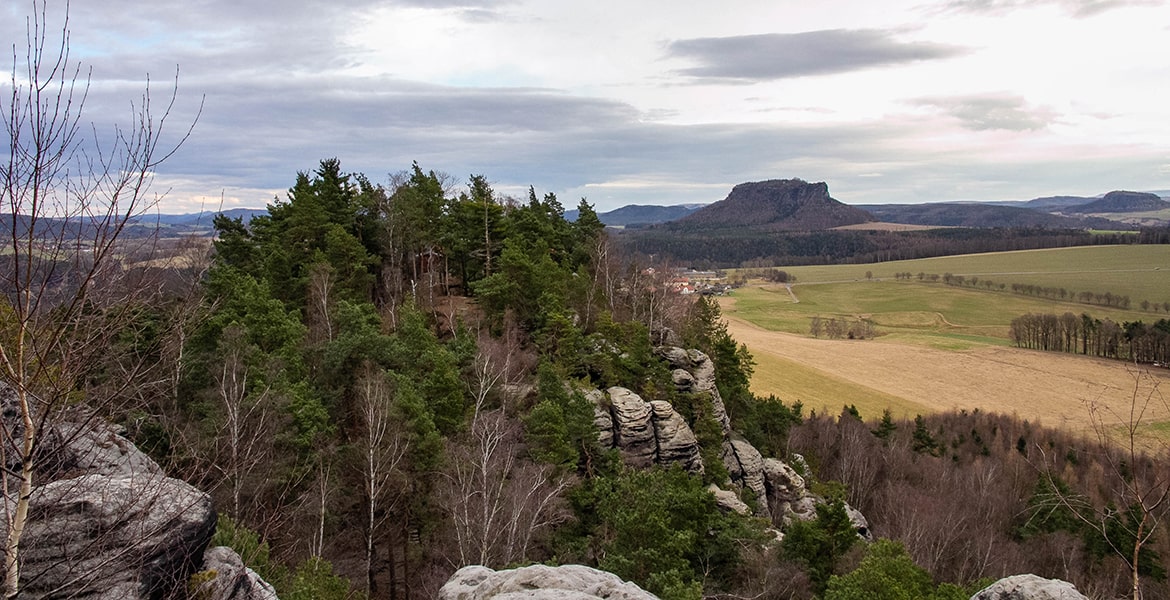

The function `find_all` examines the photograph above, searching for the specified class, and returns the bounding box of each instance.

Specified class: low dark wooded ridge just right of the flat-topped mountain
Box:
[865,202,1126,229]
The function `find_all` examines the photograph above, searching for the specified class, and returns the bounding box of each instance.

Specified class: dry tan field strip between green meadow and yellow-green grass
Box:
[724,304,1170,430]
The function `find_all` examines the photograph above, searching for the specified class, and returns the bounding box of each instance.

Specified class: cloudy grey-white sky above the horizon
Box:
[0,0,1170,213]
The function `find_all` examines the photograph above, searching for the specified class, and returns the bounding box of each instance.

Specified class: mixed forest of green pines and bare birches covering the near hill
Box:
[0,159,1170,600]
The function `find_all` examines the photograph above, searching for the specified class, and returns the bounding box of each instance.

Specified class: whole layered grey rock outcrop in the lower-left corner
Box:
[0,382,275,600]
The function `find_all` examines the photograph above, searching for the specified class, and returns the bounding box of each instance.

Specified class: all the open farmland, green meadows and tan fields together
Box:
[723,246,1170,439]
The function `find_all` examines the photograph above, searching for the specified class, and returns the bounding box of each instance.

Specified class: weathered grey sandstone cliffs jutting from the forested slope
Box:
[594,346,870,539]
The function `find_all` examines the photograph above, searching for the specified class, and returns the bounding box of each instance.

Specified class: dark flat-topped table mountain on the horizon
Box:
[667,179,874,232]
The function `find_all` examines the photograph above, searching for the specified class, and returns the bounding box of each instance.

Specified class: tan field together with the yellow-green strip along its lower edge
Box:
[723,311,1170,439]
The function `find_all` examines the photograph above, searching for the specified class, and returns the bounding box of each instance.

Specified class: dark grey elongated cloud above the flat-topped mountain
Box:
[668,29,965,81]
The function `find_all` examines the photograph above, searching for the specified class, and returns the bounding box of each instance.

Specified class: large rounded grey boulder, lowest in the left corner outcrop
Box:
[21,474,215,600]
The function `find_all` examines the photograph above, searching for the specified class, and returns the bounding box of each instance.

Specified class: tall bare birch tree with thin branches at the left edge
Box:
[0,2,194,598]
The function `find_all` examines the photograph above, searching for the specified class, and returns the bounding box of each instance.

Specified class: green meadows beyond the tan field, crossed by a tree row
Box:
[734,246,1170,341]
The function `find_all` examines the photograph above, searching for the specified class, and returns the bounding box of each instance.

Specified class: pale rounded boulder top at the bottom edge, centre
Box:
[439,565,658,600]
